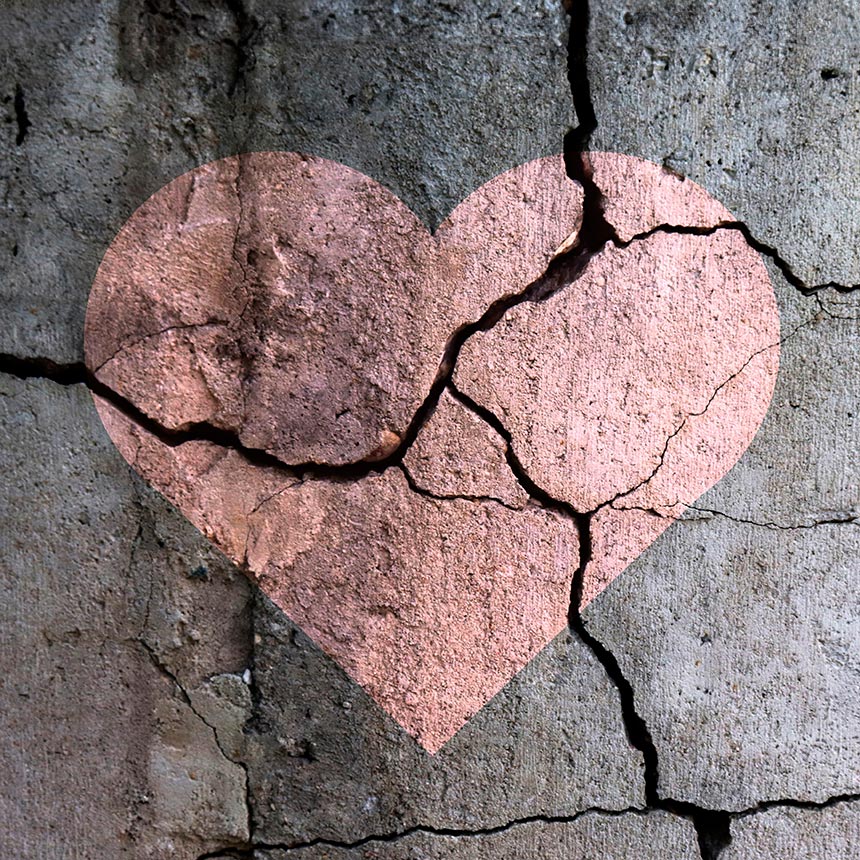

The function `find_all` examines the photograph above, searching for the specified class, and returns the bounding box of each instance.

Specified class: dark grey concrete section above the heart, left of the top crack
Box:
[0,0,572,361]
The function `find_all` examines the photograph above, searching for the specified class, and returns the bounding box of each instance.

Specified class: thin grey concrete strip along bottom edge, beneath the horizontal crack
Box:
[259,812,700,860]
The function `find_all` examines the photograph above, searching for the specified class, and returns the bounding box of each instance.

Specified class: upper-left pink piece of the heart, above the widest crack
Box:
[85,152,582,464]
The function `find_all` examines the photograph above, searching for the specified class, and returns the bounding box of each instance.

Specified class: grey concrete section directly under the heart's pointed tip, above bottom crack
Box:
[246,597,644,844]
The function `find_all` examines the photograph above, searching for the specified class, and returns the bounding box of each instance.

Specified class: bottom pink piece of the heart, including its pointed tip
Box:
[98,394,579,752]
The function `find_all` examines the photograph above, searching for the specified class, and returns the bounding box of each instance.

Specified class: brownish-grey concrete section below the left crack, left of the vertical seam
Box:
[0,376,248,858]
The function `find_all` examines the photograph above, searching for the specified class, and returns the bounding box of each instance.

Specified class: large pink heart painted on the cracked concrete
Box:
[85,152,779,753]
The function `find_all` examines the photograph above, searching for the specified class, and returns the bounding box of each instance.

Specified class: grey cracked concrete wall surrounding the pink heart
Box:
[0,0,860,860]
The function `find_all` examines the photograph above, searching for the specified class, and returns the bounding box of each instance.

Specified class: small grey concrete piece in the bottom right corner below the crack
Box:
[720,803,860,860]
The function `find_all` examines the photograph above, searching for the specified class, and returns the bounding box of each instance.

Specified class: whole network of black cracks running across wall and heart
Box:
[0,5,860,860]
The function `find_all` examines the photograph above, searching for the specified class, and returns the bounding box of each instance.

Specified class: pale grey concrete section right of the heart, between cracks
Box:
[587,275,860,810]
